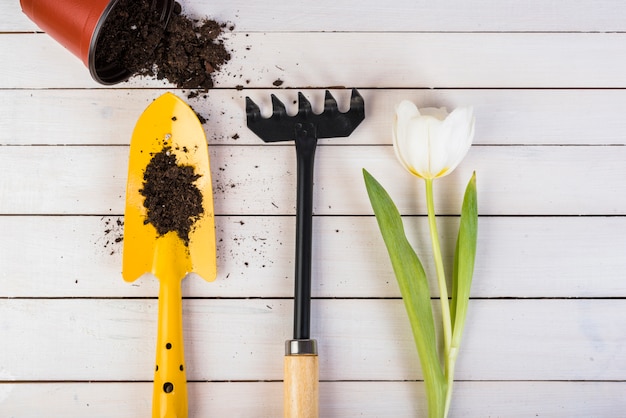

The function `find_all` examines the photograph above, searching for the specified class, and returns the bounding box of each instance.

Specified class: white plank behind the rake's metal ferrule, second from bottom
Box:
[0,299,626,384]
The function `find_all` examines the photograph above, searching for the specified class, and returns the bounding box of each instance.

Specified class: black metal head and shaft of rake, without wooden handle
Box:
[246,89,365,340]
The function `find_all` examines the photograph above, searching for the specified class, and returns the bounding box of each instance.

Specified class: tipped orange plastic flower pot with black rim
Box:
[20,0,174,84]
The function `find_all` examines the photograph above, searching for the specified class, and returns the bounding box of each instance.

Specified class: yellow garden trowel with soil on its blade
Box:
[122,93,216,418]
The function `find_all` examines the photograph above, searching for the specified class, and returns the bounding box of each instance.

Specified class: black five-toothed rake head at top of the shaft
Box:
[246,89,365,142]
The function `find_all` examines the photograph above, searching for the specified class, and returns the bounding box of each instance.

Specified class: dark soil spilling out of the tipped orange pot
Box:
[95,0,232,90]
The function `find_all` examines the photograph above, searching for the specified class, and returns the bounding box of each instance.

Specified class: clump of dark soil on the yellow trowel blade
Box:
[139,146,204,245]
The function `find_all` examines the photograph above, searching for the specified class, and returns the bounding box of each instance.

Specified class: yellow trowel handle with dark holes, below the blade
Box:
[152,278,187,418]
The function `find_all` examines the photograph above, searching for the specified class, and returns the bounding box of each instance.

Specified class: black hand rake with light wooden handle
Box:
[246,89,365,418]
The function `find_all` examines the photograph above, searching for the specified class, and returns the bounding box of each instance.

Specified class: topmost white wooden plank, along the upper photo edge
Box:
[7,0,626,32]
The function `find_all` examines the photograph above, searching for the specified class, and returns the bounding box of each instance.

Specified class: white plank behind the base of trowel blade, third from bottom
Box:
[0,216,626,303]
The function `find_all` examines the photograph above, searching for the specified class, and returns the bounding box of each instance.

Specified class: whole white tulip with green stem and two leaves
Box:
[363,100,478,418]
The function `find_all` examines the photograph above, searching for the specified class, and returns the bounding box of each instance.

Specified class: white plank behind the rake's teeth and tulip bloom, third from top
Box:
[0,89,626,146]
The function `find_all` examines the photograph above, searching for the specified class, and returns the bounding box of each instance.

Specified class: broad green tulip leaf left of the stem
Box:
[363,169,447,417]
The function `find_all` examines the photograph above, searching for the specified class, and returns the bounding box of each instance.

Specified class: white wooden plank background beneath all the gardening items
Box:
[0,0,626,418]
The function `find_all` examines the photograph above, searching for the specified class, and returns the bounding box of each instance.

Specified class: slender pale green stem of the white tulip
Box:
[425,179,452,358]
